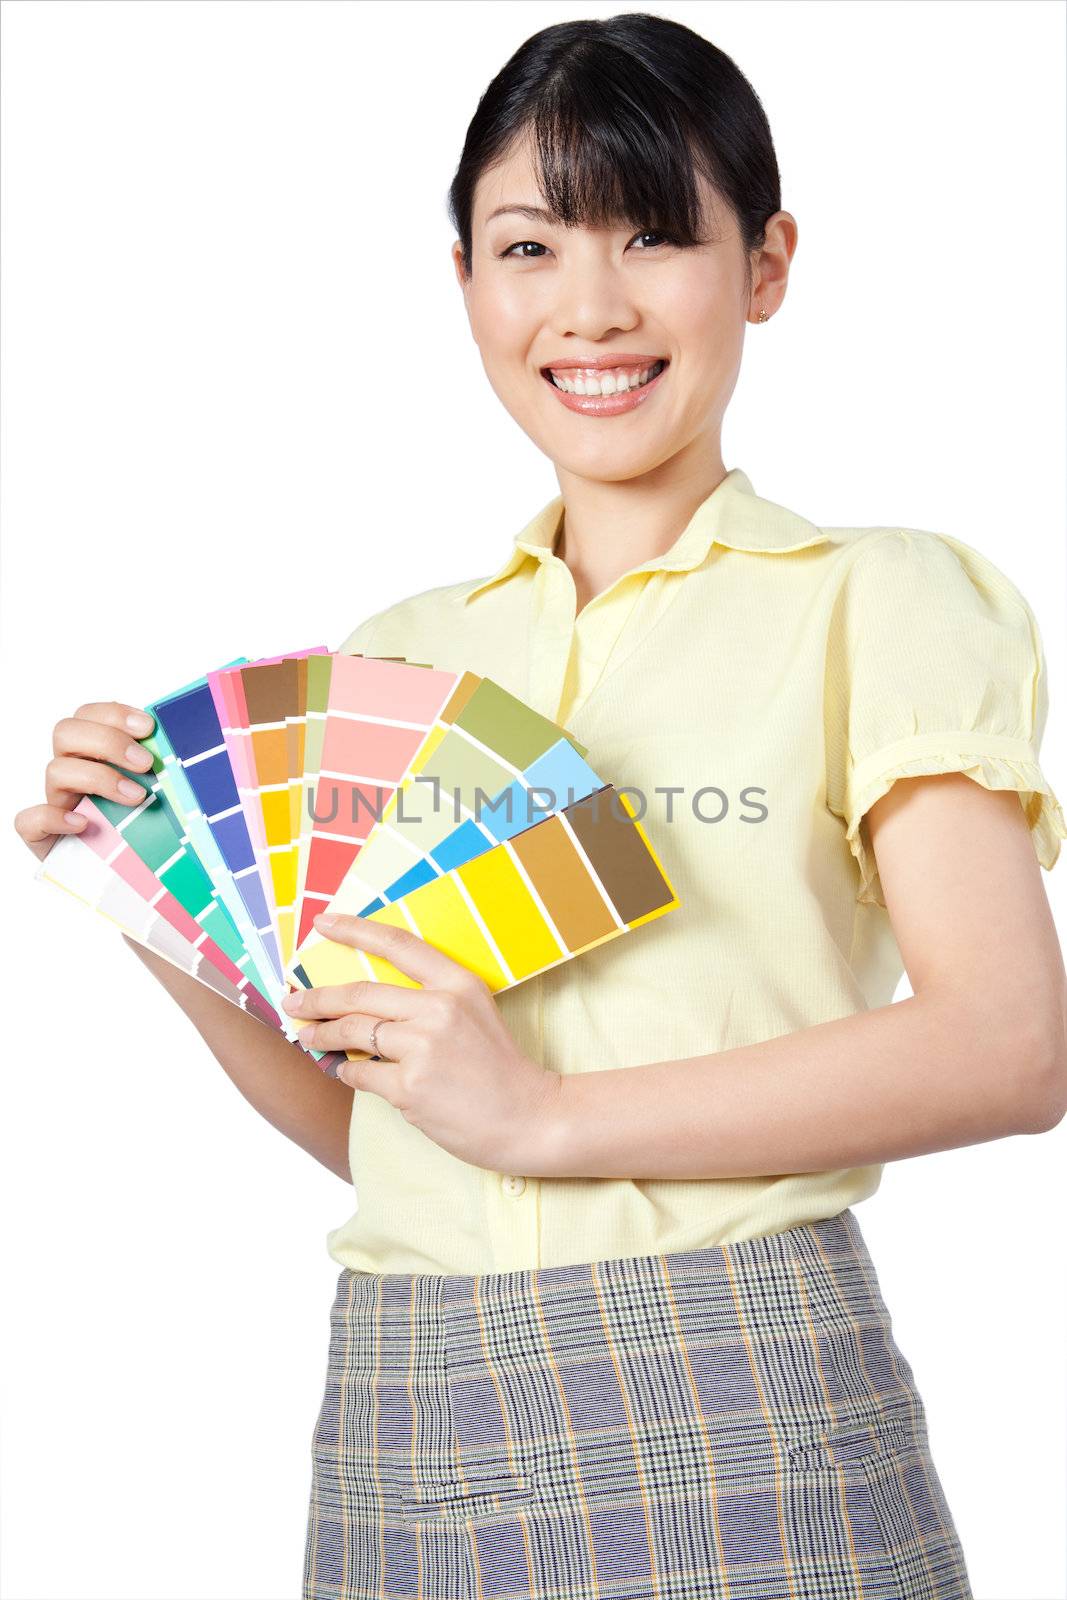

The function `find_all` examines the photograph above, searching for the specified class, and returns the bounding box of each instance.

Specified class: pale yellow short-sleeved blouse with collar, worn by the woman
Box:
[326,467,1067,1272]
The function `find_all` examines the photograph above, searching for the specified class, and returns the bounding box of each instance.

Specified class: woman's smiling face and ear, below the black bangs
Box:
[453,132,795,482]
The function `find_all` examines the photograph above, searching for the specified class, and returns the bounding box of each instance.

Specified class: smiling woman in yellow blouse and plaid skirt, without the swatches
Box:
[18,13,1067,1600]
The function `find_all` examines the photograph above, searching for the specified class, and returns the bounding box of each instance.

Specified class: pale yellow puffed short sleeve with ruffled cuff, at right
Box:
[824,530,1067,906]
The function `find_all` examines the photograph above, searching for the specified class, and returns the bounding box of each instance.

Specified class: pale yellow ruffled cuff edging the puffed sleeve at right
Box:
[845,733,1067,906]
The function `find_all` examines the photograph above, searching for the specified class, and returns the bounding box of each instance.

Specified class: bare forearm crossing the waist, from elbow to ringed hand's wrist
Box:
[531,997,1059,1178]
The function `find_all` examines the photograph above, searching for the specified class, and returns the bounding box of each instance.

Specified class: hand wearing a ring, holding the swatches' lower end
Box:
[283,915,563,1176]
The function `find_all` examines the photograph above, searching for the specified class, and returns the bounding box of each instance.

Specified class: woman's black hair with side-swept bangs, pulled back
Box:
[448,11,782,277]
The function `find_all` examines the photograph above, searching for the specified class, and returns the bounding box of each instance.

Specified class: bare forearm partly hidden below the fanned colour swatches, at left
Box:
[123,934,354,1182]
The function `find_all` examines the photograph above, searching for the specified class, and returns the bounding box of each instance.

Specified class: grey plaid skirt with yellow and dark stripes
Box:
[302,1210,973,1600]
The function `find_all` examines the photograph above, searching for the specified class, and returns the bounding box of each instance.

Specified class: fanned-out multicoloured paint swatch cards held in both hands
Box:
[37,645,678,1075]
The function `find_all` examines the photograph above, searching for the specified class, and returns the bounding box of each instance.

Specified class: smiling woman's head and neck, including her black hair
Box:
[450,60,783,610]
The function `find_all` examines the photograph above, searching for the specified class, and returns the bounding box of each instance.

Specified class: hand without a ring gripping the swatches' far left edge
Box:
[14,701,155,861]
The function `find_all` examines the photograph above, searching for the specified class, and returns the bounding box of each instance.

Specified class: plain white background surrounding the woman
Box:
[0,0,1067,1600]
